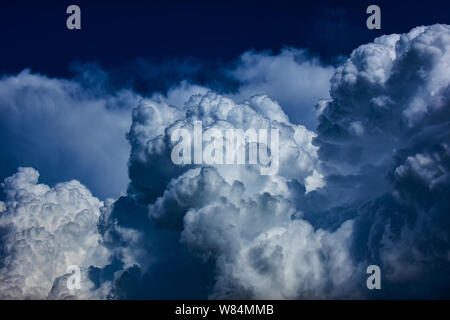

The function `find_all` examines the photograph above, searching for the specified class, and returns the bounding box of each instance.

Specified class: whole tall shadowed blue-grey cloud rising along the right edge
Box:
[310,25,450,298]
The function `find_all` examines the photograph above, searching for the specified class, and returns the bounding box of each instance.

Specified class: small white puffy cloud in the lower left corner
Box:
[0,168,109,299]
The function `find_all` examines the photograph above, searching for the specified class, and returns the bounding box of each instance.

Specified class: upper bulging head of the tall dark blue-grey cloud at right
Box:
[316,25,450,178]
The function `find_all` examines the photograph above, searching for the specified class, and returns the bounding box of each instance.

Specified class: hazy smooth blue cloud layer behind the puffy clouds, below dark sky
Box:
[0,49,332,198]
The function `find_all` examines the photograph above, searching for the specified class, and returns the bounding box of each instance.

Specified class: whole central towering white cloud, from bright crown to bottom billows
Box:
[101,86,357,298]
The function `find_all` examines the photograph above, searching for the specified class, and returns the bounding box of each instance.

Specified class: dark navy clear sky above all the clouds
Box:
[0,0,450,76]
